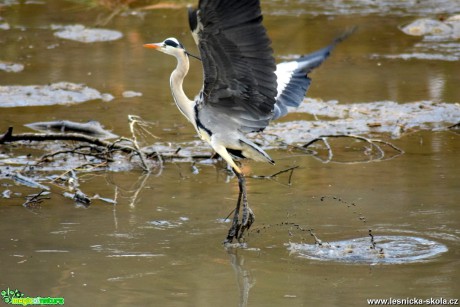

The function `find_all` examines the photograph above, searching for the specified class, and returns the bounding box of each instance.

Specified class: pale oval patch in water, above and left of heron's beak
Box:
[52,25,123,43]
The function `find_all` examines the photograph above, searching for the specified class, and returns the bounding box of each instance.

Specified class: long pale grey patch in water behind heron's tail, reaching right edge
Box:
[262,98,460,148]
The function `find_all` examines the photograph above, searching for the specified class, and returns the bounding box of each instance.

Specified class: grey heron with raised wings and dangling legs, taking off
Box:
[144,0,347,243]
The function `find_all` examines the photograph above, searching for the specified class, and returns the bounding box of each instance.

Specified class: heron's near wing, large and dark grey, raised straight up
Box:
[189,0,276,132]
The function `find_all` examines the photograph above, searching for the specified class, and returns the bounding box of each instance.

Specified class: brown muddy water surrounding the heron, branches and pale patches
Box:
[0,1,460,306]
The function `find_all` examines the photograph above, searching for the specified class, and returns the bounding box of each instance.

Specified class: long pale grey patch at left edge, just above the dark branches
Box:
[0,82,114,108]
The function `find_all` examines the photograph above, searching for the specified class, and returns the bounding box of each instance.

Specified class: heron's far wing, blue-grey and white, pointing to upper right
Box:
[273,28,355,119]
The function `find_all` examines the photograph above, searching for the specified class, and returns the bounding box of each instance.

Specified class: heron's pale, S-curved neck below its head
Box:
[169,52,195,124]
